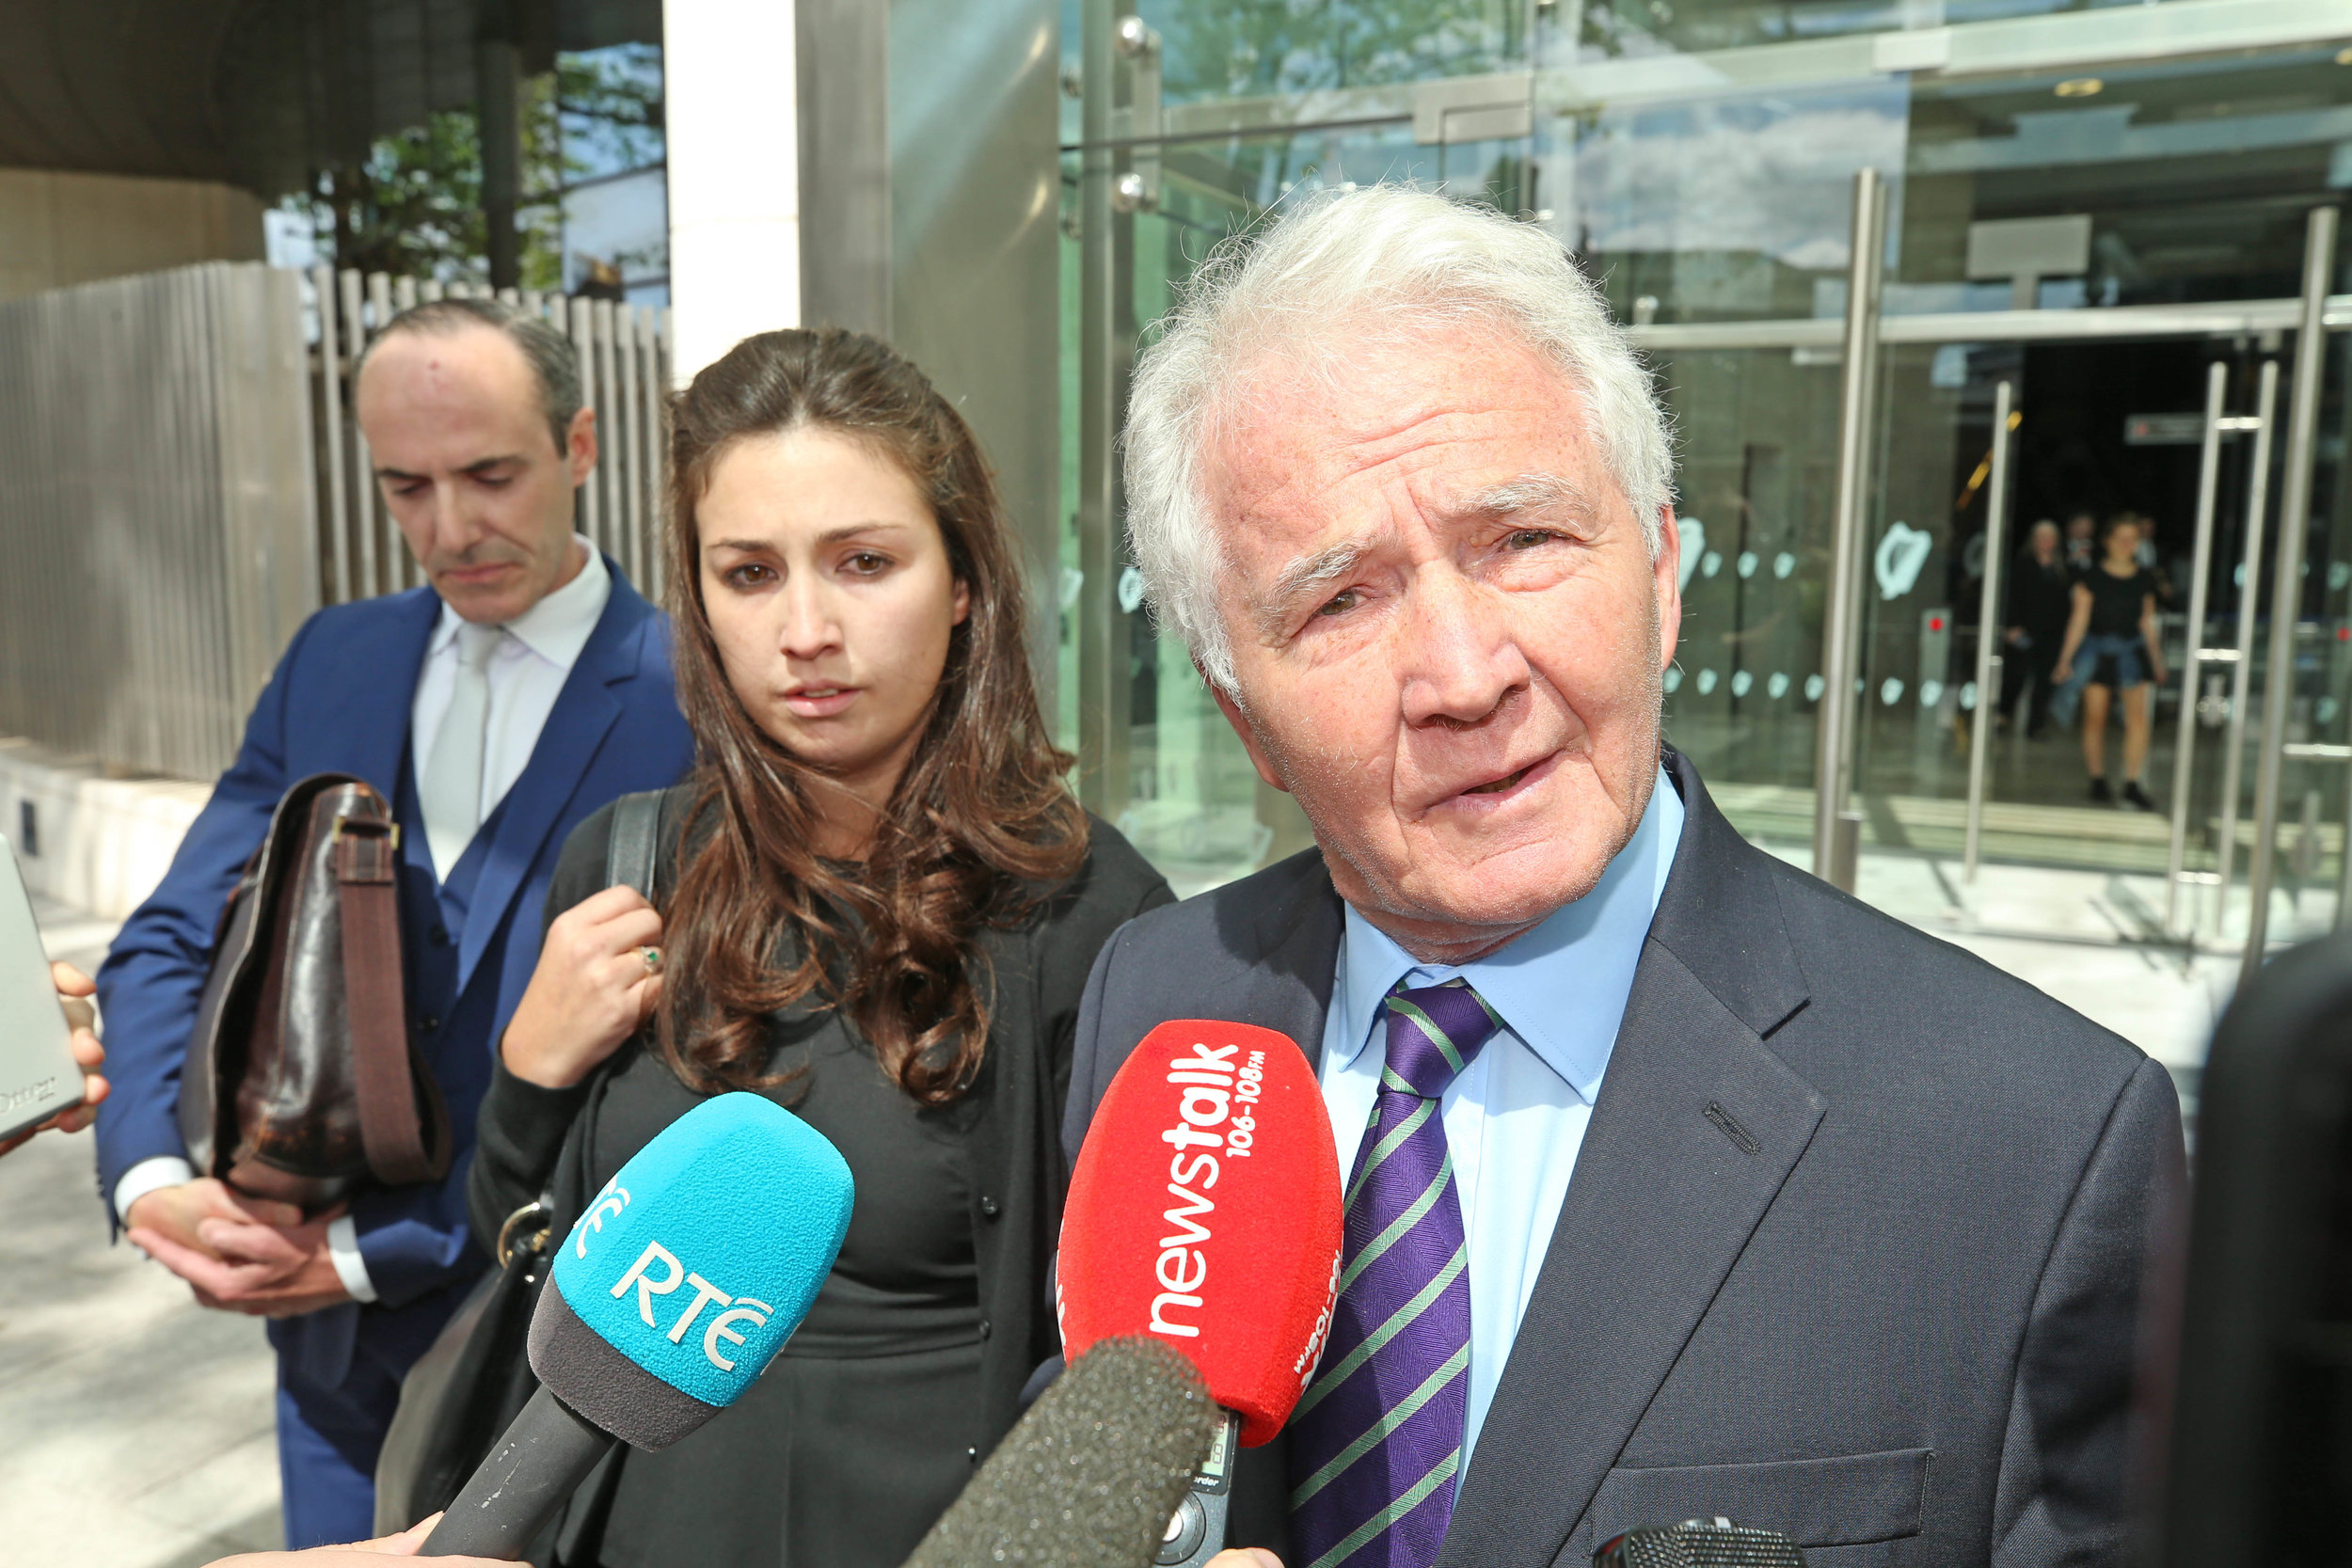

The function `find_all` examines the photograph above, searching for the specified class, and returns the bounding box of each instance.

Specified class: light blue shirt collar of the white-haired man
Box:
[1331,768,1684,1105]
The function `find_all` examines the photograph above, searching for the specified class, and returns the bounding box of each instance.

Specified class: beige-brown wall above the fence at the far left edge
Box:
[0,169,262,301]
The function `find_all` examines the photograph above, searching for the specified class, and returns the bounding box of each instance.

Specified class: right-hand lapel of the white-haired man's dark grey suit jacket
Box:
[1439,757,1825,1568]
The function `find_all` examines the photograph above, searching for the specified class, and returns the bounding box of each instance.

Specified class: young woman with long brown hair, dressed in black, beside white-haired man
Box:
[470,331,1169,1568]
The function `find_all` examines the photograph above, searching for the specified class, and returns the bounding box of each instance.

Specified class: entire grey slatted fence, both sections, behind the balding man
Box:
[0,261,671,778]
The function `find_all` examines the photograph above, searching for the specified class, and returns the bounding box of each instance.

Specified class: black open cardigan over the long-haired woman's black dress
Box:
[469,785,1171,1476]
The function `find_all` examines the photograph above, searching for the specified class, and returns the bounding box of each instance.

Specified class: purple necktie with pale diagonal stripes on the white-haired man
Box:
[1289,980,1501,1568]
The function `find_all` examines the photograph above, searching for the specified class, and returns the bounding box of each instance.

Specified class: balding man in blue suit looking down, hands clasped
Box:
[99,301,694,1547]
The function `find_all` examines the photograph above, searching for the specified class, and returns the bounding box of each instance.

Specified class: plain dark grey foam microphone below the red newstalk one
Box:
[903,1336,1226,1568]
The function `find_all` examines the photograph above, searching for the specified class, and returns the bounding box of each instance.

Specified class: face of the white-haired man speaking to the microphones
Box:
[1209,326,1682,961]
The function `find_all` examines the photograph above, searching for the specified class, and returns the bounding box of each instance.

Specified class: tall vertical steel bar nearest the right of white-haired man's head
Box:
[1814,169,1884,894]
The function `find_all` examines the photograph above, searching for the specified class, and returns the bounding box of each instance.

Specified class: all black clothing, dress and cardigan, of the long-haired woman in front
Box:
[469,785,1171,1568]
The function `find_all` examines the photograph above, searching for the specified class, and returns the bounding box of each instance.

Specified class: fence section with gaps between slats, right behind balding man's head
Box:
[304,265,671,604]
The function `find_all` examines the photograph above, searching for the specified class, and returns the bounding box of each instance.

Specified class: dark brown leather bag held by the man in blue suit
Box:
[179,773,450,1211]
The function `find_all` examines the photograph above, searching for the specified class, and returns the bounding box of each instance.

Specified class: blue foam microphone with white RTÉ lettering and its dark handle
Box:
[419,1093,854,1561]
